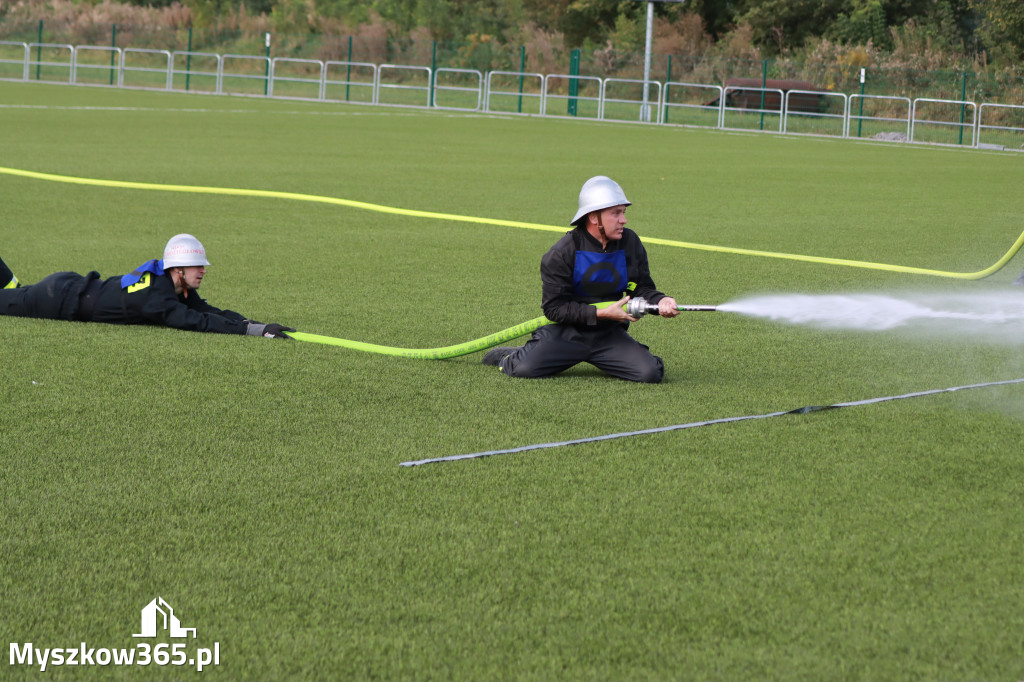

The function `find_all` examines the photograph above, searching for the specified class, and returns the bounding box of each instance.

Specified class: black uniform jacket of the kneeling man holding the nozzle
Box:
[541,227,665,328]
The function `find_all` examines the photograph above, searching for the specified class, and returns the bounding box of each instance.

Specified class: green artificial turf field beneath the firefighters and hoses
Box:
[0,83,1024,680]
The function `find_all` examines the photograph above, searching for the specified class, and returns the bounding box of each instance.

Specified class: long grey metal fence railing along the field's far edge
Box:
[0,41,1024,151]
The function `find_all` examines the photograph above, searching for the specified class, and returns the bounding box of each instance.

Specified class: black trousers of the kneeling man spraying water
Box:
[499,325,665,384]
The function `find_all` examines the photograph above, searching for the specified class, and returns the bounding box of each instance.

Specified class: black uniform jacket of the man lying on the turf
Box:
[86,272,249,334]
